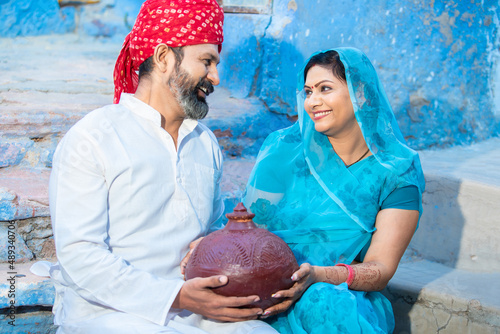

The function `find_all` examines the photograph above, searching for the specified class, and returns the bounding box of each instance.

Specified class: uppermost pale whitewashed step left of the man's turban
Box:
[0,34,121,96]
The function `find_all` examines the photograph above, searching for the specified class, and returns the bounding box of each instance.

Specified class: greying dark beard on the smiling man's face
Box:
[168,67,214,119]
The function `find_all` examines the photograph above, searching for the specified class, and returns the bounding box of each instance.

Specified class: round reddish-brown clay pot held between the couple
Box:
[185,203,299,310]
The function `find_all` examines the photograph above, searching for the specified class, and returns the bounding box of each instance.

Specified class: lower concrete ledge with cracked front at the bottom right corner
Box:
[384,260,500,334]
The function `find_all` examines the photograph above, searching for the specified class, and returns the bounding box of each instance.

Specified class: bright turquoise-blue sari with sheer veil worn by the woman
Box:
[243,48,425,334]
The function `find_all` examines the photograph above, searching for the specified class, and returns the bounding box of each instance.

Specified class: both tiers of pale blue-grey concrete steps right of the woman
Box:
[384,138,500,334]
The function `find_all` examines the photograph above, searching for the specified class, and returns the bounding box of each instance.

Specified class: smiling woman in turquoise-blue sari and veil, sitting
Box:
[243,48,424,333]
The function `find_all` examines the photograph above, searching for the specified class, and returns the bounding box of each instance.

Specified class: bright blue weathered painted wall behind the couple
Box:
[0,0,500,149]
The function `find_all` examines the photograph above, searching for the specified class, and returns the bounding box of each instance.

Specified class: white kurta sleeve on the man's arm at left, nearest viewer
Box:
[49,129,184,325]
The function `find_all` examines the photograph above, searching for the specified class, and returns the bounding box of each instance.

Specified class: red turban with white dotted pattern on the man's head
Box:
[114,0,224,103]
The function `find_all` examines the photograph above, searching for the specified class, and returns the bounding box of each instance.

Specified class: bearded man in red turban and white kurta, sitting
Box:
[49,0,276,334]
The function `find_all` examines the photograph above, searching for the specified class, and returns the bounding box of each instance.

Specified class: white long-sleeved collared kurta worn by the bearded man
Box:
[49,94,278,334]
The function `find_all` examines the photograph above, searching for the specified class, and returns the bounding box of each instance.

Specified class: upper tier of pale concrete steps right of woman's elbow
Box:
[410,138,500,273]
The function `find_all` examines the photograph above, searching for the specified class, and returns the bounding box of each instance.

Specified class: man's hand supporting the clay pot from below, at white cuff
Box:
[172,276,262,322]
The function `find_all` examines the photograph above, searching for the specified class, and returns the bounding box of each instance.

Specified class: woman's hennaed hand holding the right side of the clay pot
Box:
[260,263,316,319]
